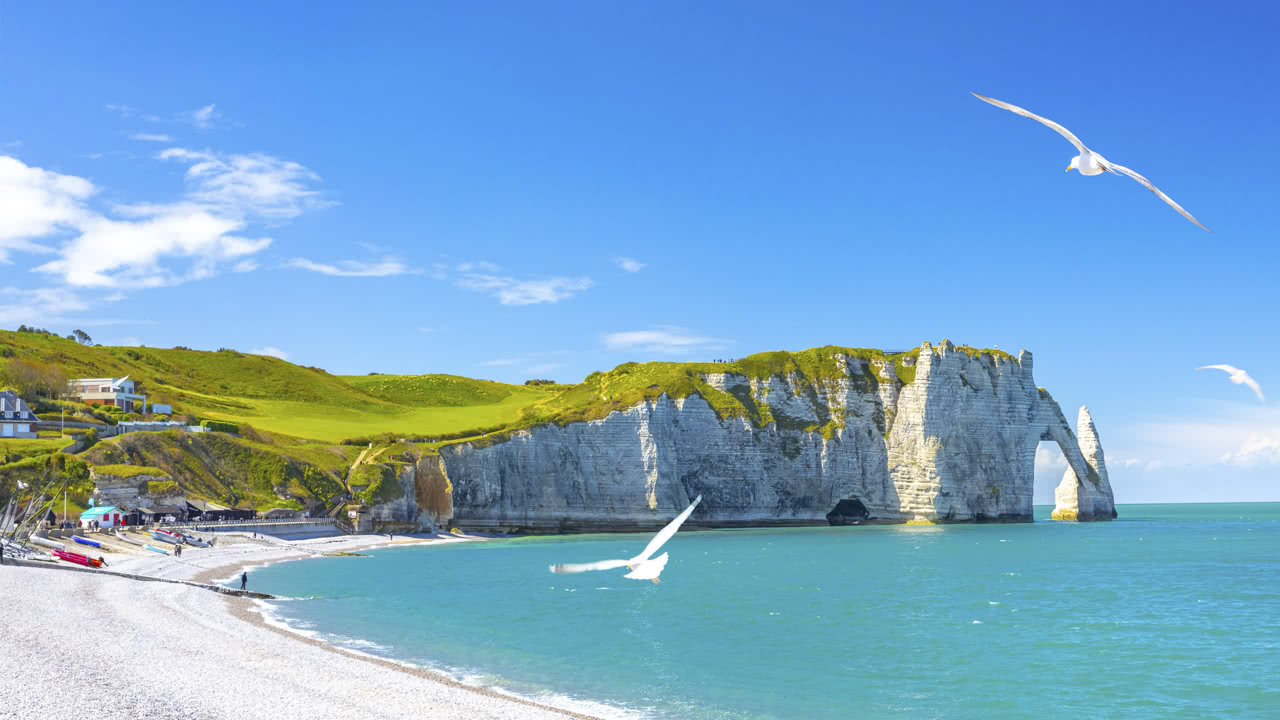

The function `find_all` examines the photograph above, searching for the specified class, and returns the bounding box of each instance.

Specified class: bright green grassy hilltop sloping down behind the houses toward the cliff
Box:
[0,331,557,441]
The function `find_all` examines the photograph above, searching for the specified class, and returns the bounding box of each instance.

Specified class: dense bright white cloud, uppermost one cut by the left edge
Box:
[0,156,97,263]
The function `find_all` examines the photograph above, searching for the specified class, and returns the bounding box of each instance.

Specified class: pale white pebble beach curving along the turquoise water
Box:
[0,536,601,720]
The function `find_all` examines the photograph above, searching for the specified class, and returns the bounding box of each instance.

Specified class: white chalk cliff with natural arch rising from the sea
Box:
[440,342,1114,532]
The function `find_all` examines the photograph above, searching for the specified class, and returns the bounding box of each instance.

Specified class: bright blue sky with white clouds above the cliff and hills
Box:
[0,3,1280,502]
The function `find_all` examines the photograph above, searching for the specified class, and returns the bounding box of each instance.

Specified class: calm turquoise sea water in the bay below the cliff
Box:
[252,503,1280,719]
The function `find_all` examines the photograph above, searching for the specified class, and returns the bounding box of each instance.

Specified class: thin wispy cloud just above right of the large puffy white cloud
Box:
[157,147,333,220]
